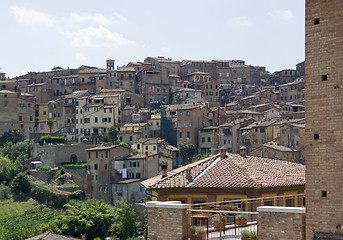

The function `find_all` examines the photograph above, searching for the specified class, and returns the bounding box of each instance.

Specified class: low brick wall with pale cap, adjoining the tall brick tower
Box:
[257,207,305,240]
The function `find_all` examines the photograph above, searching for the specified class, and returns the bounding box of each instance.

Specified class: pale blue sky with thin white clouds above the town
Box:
[0,0,305,77]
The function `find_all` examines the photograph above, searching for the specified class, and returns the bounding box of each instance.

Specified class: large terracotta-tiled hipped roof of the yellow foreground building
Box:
[142,154,305,189]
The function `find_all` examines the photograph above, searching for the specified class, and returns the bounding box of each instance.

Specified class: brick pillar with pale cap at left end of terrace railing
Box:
[146,201,189,240]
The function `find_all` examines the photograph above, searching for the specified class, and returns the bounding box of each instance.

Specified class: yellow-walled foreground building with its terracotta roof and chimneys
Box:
[142,149,305,206]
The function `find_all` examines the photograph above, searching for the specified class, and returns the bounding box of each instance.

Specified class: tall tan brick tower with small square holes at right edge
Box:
[305,0,343,240]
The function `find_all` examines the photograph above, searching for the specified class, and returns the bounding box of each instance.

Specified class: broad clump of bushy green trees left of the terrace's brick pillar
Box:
[50,199,139,240]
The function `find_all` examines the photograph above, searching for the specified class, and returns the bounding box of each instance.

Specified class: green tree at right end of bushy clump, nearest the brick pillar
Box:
[111,200,139,239]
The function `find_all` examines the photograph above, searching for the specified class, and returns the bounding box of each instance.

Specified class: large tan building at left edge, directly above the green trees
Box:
[0,90,35,139]
